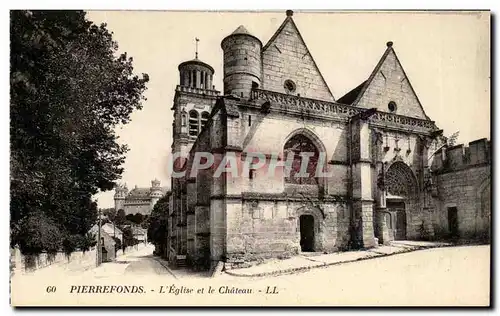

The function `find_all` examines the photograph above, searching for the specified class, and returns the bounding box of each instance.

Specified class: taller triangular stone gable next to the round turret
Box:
[262,17,335,101]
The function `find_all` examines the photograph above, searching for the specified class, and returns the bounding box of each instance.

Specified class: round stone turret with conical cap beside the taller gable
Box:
[221,25,262,98]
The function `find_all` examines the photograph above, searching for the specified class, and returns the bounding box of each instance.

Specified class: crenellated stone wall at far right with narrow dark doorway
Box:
[432,139,491,239]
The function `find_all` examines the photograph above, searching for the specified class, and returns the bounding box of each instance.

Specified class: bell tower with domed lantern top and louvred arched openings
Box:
[172,39,219,157]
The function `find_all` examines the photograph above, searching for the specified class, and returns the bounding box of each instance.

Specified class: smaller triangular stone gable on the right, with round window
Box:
[353,43,429,120]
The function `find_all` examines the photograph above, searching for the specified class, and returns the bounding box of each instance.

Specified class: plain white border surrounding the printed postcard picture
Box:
[0,0,500,315]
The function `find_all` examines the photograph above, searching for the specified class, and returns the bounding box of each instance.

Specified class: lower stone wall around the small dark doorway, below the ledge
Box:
[227,198,349,265]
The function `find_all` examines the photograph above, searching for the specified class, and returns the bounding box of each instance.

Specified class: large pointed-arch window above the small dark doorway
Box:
[283,134,319,184]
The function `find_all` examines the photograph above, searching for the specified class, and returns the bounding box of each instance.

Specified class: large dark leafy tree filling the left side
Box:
[10,11,149,252]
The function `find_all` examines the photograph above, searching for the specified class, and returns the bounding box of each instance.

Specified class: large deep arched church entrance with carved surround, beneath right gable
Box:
[385,161,418,240]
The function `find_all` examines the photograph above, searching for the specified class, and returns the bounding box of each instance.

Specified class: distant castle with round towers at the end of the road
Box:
[115,179,168,215]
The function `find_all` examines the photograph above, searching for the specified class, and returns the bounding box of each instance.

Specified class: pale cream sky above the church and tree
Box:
[87,10,490,208]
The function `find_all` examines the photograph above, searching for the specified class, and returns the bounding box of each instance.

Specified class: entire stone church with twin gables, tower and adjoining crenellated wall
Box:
[167,11,490,267]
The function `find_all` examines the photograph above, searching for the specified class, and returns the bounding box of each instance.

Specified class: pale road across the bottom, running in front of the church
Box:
[9,246,490,306]
